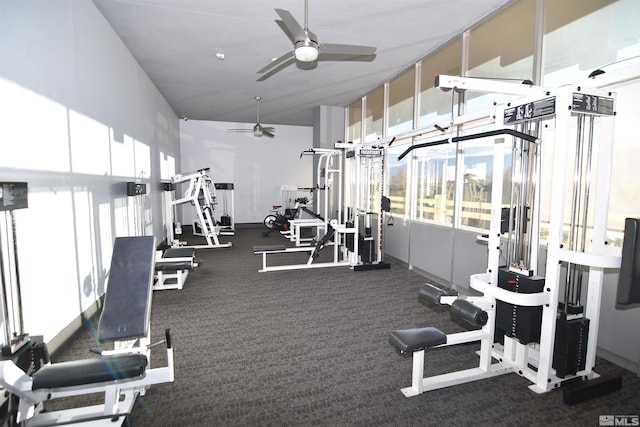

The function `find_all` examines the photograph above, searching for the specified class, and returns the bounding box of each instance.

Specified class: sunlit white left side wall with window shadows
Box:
[0,0,180,348]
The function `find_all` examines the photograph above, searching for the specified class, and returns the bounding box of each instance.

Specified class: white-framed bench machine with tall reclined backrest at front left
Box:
[0,237,174,426]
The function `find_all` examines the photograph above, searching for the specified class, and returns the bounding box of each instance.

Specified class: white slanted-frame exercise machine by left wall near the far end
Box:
[164,168,232,249]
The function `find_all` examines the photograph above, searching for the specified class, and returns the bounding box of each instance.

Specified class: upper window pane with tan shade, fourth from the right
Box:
[387,67,415,136]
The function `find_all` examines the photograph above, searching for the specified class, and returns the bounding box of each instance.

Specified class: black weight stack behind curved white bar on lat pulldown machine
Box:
[495,269,544,344]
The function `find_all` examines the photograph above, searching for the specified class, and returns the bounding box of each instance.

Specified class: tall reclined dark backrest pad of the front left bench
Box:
[98,236,155,342]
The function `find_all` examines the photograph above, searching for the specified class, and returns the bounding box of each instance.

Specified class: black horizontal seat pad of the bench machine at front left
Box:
[31,353,147,390]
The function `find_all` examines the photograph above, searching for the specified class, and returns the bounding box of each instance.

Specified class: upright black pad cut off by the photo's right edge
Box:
[616,218,640,305]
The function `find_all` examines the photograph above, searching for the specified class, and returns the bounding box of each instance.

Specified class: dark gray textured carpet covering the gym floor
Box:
[52,229,640,426]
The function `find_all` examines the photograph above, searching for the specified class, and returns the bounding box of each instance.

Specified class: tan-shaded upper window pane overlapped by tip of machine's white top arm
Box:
[418,37,462,127]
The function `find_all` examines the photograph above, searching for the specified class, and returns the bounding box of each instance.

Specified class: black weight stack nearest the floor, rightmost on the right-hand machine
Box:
[552,314,589,378]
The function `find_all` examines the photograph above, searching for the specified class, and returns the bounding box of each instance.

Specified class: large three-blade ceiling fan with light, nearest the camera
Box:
[258,0,376,81]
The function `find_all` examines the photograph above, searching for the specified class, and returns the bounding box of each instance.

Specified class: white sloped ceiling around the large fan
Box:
[93,0,509,126]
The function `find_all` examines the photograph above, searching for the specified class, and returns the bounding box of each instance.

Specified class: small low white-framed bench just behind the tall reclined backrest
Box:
[153,247,202,291]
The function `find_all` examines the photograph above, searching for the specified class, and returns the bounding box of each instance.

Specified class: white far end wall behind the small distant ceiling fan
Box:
[180,120,314,224]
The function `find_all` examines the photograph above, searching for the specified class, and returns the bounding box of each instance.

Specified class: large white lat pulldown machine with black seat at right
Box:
[389,76,621,403]
